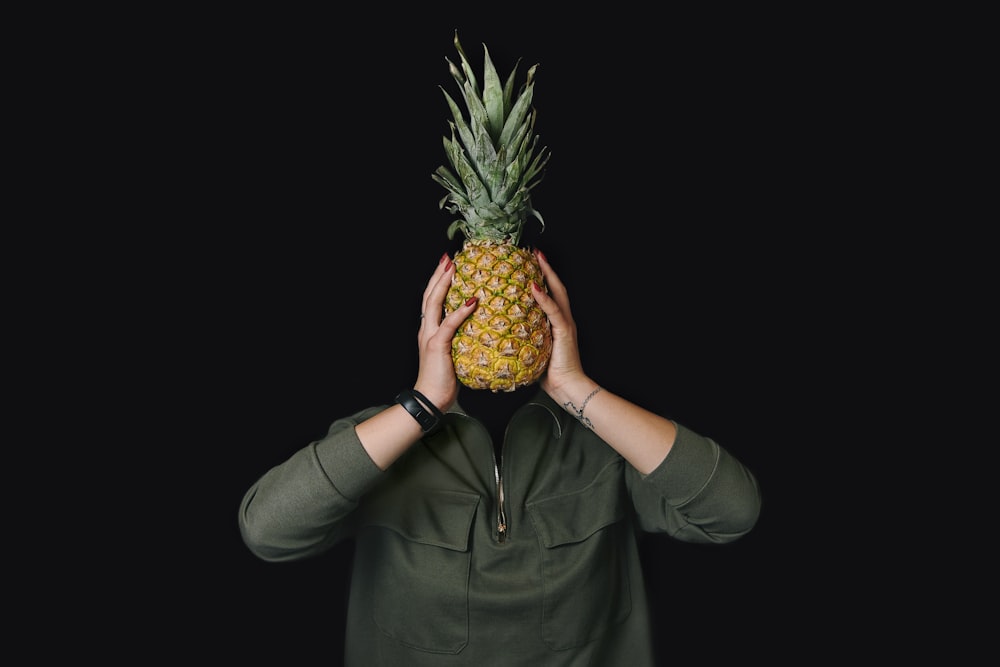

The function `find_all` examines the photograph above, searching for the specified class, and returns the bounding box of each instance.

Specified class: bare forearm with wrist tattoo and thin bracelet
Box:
[552,378,677,475]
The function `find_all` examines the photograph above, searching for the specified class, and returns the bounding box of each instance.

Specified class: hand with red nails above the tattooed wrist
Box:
[532,249,587,396]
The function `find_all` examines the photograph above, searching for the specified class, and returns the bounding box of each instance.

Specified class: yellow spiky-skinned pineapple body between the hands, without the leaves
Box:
[445,239,552,392]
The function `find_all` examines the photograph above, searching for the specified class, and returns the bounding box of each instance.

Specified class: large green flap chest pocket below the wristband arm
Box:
[359,490,479,653]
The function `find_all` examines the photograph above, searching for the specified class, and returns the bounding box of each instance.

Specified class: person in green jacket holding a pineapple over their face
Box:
[239,250,761,667]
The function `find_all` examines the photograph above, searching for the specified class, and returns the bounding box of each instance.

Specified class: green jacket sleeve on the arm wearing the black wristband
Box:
[239,406,385,561]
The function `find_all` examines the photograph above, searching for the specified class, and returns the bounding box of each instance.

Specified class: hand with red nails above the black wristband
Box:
[413,253,477,412]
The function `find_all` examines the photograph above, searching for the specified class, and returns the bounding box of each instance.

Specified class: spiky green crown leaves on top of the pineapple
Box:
[431,32,549,243]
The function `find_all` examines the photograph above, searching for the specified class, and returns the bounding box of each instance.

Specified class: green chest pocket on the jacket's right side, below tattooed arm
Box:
[526,466,632,650]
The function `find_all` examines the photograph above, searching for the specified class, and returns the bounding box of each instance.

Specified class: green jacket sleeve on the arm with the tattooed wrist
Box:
[628,424,761,544]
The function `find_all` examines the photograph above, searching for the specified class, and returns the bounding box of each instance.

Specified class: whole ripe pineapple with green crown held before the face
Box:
[432,32,552,392]
